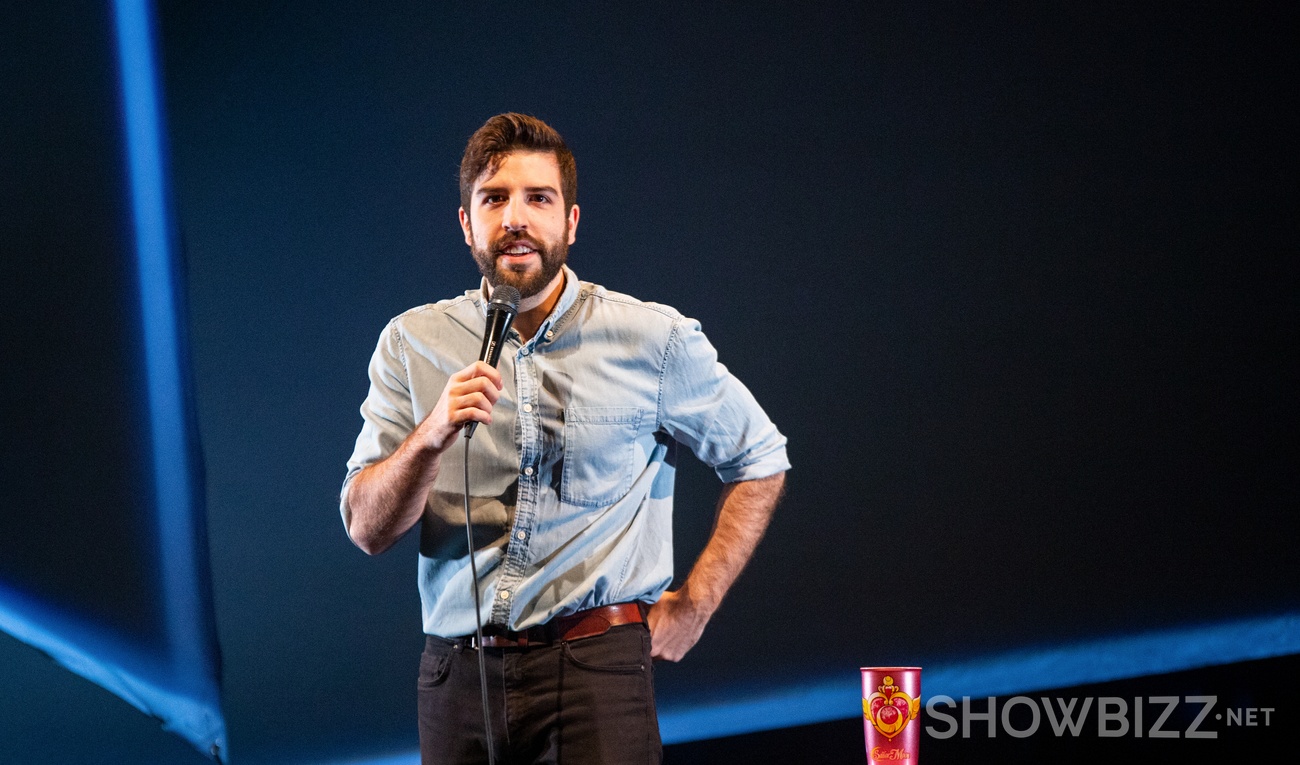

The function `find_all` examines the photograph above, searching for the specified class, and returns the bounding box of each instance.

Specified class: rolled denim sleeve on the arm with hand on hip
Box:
[659,317,790,483]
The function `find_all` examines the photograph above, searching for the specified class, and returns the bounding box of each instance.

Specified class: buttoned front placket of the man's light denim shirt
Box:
[491,342,542,624]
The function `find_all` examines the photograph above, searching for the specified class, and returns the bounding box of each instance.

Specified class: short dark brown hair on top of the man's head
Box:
[460,112,577,212]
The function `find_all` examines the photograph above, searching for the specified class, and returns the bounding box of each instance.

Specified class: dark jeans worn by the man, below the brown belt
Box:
[420,624,663,765]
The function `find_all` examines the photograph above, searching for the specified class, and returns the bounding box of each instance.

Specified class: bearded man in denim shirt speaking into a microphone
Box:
[341,113,789,765]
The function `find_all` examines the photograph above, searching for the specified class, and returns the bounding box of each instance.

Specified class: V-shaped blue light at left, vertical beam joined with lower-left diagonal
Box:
[0,0,226,755]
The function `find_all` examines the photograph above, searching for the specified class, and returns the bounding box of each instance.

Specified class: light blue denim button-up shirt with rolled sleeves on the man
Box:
[342,268,789,638]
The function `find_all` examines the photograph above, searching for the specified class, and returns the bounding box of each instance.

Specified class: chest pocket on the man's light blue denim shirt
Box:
[560,406,641,507]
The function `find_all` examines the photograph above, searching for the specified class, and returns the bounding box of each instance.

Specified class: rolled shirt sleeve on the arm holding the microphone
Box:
[339,320,416,523]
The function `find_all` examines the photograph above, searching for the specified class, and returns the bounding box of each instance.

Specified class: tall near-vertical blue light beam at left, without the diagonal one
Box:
[113,0,225,752]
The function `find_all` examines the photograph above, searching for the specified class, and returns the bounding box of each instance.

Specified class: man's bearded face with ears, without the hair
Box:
[460,151,577,299]
